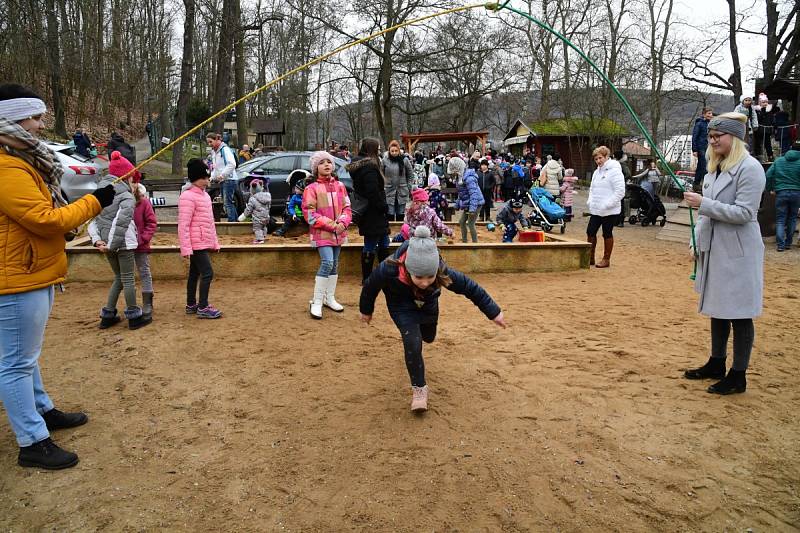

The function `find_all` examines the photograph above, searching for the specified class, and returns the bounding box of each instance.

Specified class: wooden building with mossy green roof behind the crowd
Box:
[503,118,627,179]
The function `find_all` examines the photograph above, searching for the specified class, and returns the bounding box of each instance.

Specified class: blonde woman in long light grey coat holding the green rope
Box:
[683,113,766,394]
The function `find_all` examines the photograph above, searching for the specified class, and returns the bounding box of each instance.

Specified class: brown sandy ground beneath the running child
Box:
[0,226,800,532]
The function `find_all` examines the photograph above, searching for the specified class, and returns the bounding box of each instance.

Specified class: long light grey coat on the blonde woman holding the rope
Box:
[695,156,766,319]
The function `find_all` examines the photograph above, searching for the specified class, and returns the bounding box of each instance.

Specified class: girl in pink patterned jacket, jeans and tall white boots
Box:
[303,152,352,319]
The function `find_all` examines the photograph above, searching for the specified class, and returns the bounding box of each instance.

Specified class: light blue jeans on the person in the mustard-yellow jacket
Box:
[0,287,53,446]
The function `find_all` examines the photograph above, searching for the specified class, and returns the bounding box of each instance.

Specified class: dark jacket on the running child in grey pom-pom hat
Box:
[359,241,500,324]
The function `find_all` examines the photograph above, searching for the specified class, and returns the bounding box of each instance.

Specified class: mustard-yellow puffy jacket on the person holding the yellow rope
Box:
[0,149,100,294]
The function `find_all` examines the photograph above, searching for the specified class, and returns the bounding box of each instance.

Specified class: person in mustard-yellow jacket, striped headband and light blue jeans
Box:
[0,84,114,469]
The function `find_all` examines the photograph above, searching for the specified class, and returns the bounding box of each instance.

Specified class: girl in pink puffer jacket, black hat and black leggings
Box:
[178,159,222,318]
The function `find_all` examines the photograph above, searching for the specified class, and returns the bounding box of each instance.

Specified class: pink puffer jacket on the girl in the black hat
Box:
[178,185,219,257]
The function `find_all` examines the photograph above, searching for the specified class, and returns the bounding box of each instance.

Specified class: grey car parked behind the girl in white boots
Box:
[208,152,353,215]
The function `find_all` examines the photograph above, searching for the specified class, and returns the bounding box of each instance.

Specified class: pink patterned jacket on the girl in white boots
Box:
[303,176,352,247]
